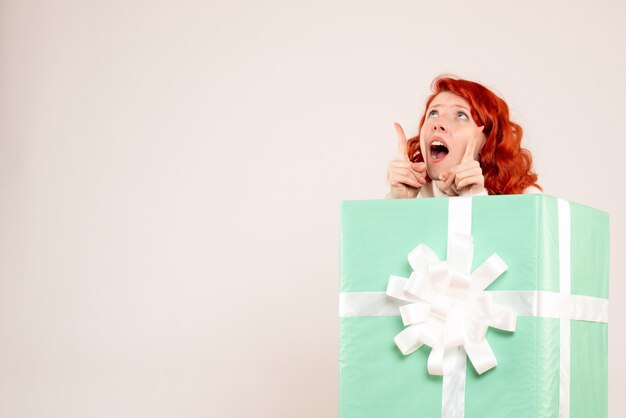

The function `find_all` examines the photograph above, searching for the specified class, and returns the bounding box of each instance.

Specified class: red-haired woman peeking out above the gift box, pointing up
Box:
[388,76,541,199]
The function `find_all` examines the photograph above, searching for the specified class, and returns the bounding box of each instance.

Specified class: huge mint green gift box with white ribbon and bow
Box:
[339,195,609,418]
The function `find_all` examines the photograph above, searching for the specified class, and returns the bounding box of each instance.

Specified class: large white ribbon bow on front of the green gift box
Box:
[386,233,517,376]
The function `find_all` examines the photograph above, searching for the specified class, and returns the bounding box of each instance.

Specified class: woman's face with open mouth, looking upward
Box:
[420,91,486,180]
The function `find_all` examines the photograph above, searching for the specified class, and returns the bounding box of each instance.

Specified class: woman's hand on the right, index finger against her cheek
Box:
[441,126,486,196]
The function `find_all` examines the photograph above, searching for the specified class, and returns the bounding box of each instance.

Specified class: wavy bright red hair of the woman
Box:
[408,76,541,195]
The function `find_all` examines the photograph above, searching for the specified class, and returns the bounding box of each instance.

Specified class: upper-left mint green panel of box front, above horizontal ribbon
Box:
[340,198,448,292]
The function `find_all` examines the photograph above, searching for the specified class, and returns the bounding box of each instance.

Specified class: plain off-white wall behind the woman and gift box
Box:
[0,0,626,418]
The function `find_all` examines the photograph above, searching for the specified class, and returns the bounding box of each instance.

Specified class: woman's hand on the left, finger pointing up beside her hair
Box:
[387,123,426,199]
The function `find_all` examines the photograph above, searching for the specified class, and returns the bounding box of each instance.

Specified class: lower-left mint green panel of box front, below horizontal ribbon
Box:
[339,317,442,418]
